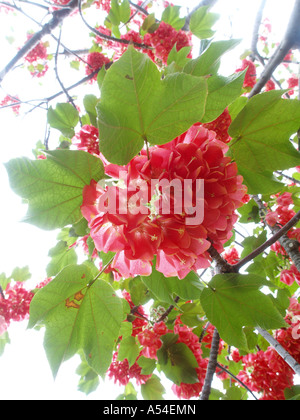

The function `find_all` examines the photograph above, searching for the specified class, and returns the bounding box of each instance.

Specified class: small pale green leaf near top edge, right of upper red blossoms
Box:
[190,6,220,39]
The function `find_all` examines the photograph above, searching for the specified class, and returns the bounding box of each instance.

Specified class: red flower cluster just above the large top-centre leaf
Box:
[144,22,192,64]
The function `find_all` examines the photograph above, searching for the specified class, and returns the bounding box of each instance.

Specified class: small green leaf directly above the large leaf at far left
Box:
[47,103,79,138]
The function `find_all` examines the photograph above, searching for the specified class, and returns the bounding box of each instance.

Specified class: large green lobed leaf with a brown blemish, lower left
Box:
[28,265,123,378]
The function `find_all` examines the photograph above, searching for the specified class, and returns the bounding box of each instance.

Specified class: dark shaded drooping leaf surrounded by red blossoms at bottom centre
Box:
[157,333,198,385]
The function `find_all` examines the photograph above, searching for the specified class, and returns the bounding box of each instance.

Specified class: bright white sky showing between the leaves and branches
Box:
[0,0,294,400]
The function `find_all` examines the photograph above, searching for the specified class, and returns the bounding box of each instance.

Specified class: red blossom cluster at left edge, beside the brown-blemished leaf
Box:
[0,278,51,335]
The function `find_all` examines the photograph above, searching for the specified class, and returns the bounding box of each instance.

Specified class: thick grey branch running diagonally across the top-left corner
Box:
[0,0,78,83]
